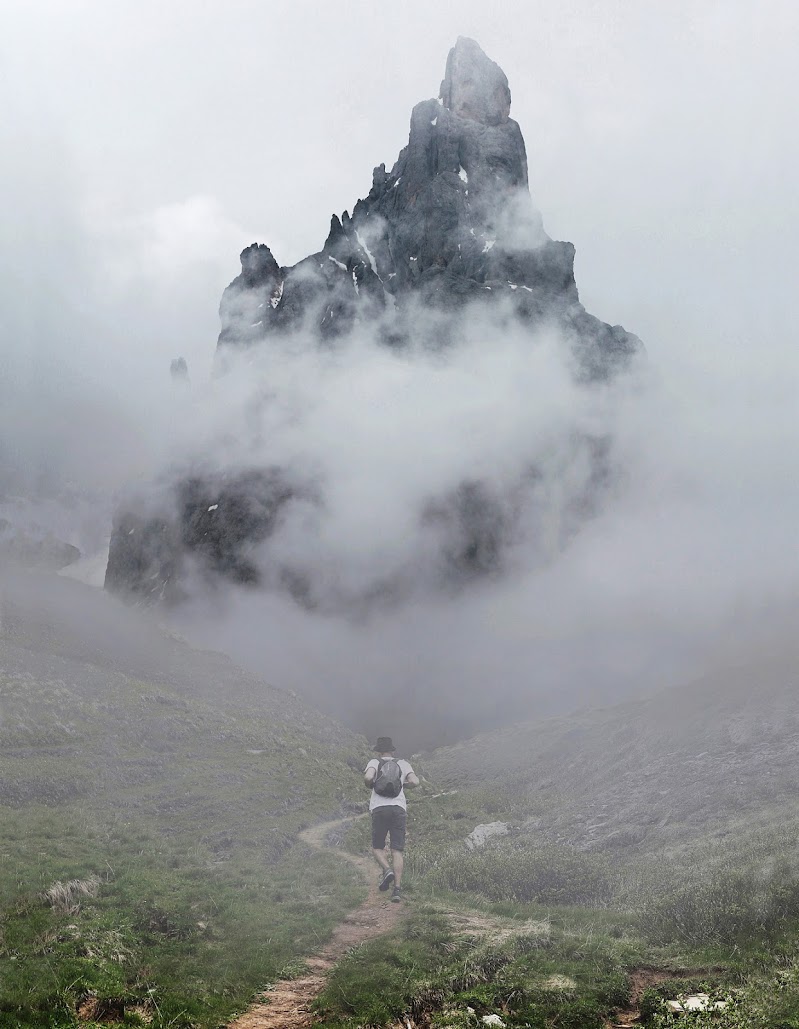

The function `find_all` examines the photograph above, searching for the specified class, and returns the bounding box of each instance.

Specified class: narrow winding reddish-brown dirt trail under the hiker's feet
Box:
[228,815,404,1029]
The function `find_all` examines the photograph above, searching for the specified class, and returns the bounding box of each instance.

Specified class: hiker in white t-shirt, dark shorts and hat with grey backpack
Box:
[363,736,419,902]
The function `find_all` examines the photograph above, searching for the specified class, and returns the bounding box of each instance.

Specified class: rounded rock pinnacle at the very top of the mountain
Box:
[440,36,511,126]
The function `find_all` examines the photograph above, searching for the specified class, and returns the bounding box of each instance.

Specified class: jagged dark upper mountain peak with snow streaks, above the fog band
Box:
[219,37,639,380]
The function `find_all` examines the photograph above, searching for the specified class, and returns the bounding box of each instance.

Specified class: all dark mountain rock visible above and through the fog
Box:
[106,37,640,606]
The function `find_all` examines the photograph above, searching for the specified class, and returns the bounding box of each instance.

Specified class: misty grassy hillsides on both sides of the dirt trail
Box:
[6,572,799,1029]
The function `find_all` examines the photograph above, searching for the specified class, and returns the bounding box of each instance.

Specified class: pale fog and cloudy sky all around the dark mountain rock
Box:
[0,3,799,746]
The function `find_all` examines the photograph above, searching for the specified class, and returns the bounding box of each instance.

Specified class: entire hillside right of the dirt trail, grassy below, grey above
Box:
[319,645,799,1029]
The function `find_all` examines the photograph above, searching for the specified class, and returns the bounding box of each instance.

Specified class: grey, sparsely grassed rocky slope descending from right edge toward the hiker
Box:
[426,633,799,850]
